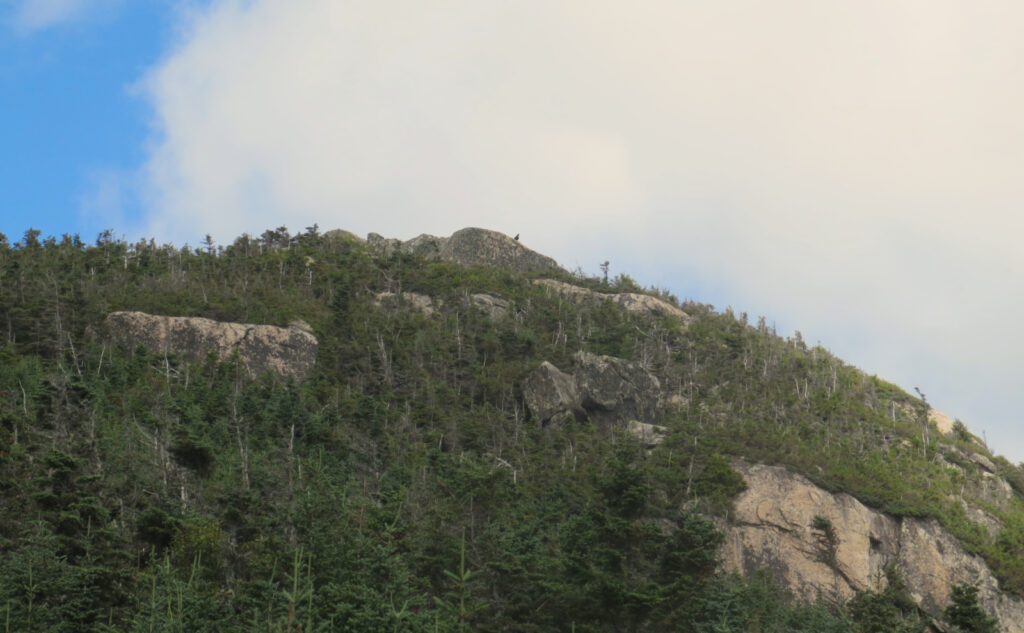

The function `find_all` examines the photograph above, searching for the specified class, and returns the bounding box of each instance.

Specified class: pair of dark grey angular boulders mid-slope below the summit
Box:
[522,351,663,424]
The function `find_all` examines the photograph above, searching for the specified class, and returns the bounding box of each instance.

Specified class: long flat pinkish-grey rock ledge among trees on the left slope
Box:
[104,311,318,381]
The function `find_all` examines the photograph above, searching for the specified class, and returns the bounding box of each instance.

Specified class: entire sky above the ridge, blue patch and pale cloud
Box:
[0,0,1024,462]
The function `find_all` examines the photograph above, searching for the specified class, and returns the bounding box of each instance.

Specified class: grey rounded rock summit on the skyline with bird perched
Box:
[367,227,562,272]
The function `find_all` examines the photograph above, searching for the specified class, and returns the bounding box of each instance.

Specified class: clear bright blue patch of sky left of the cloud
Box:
[0,1,173,240]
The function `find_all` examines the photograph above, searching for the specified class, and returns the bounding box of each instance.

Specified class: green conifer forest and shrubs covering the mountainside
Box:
[0,227,1011,633]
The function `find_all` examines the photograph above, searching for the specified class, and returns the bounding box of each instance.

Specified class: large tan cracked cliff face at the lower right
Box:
[723,462,1024,633]
